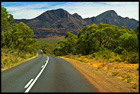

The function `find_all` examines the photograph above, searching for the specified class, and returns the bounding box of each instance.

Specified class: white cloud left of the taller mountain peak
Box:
[6,3,49,19]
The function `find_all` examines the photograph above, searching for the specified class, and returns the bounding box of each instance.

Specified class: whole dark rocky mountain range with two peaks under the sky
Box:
[10,9,139,38]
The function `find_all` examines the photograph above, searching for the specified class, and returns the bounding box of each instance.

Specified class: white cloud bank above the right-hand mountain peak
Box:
[52,2,139,20]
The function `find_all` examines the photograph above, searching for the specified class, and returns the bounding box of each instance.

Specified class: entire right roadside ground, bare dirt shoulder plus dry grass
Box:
[61,57,139,92]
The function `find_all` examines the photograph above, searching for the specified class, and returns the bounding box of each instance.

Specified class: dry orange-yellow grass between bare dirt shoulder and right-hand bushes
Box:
[60,55,139,90]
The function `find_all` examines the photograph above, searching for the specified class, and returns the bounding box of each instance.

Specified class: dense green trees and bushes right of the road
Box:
[54,23,139,63]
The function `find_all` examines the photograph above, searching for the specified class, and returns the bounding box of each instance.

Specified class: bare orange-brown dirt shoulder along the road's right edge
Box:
[61,57,138,92]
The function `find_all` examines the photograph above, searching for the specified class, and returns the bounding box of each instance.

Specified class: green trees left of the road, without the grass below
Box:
[1,7,37,54]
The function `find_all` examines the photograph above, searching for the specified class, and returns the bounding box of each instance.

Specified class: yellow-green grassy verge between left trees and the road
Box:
[1,48,38,71]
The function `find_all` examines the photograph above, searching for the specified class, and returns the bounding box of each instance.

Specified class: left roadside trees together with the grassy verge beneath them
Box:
[1,7,39,68]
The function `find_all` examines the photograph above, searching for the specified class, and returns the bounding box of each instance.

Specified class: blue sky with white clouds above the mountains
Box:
[1,2,139,20]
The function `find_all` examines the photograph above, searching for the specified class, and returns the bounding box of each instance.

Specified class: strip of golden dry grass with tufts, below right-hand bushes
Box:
[64,54,139,90]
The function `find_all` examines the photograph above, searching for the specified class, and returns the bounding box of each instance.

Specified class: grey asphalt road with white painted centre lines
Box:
[1,51,98,93]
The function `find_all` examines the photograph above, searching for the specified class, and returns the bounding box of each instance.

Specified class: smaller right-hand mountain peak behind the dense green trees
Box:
[84,10,139,30]
